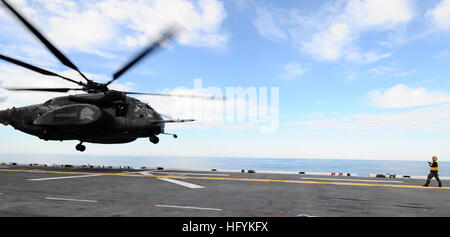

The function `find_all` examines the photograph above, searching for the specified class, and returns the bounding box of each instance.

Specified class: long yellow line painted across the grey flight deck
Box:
[0,169,450,190]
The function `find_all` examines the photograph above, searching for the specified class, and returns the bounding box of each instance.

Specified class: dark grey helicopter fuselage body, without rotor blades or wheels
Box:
[0,93,164,144]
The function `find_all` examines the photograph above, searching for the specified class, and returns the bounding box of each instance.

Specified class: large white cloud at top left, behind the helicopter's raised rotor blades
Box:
[2,0,230,54]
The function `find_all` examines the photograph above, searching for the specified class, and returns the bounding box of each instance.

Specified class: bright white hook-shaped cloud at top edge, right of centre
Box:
[303,0,414,64]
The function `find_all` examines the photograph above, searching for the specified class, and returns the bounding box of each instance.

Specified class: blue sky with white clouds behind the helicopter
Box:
[0,0,450,160]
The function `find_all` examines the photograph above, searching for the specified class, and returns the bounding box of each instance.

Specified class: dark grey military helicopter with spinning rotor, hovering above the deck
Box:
[0,0,216,152]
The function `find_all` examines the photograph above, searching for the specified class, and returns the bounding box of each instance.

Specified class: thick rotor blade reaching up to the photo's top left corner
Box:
[1,0,89,81]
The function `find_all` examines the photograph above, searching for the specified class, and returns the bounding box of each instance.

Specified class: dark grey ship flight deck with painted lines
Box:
[0,165,450,217]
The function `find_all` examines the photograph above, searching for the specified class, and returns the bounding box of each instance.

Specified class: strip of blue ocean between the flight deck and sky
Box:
[0,154,450,177]
